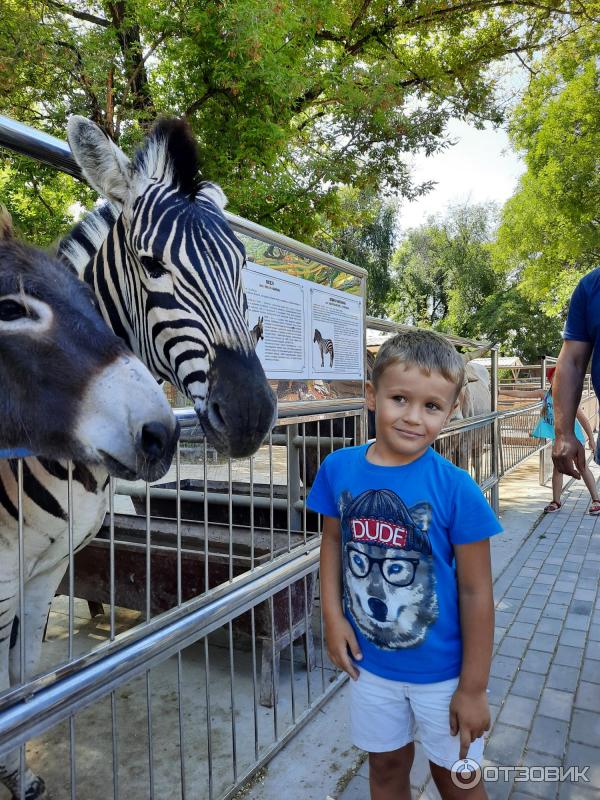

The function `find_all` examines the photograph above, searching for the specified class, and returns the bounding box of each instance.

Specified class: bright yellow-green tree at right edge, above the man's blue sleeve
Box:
[495,26,600,314]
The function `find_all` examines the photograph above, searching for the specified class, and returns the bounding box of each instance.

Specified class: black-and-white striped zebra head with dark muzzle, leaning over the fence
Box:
[61,117,276,457]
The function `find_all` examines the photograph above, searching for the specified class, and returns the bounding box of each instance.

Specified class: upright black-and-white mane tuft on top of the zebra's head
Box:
[133,118,200,199]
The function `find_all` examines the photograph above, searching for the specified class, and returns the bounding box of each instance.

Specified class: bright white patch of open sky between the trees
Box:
[399,120,525,235]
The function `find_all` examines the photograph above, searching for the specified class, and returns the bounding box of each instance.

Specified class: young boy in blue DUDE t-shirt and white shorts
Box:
[307,331,502,800]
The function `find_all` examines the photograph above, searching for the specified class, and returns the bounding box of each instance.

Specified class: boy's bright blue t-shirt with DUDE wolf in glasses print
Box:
[307,445,502,683]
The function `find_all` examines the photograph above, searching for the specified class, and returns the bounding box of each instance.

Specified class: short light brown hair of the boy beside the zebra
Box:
[371,331,465,400]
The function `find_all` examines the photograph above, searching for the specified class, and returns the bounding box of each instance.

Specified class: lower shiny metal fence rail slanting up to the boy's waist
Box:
[0,539,320,754]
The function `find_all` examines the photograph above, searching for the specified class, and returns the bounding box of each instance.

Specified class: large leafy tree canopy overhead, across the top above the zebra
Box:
[0,0,589,244]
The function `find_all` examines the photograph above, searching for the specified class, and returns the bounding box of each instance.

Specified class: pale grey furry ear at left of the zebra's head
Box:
[67,115,132,208]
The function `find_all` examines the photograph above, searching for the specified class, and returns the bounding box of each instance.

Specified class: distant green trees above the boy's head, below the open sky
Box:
[389,204,562,361]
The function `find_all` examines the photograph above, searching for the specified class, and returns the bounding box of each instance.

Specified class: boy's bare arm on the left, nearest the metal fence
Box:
[319,516,362,680]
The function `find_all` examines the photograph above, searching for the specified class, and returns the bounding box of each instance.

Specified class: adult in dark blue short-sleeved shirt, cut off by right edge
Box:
[552,269,600,479]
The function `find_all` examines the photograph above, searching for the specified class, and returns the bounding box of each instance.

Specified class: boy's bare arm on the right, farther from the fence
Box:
[450,539,494,758]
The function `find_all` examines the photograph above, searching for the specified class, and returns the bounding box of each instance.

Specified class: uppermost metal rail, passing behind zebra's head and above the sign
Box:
[0,115,367,278]
